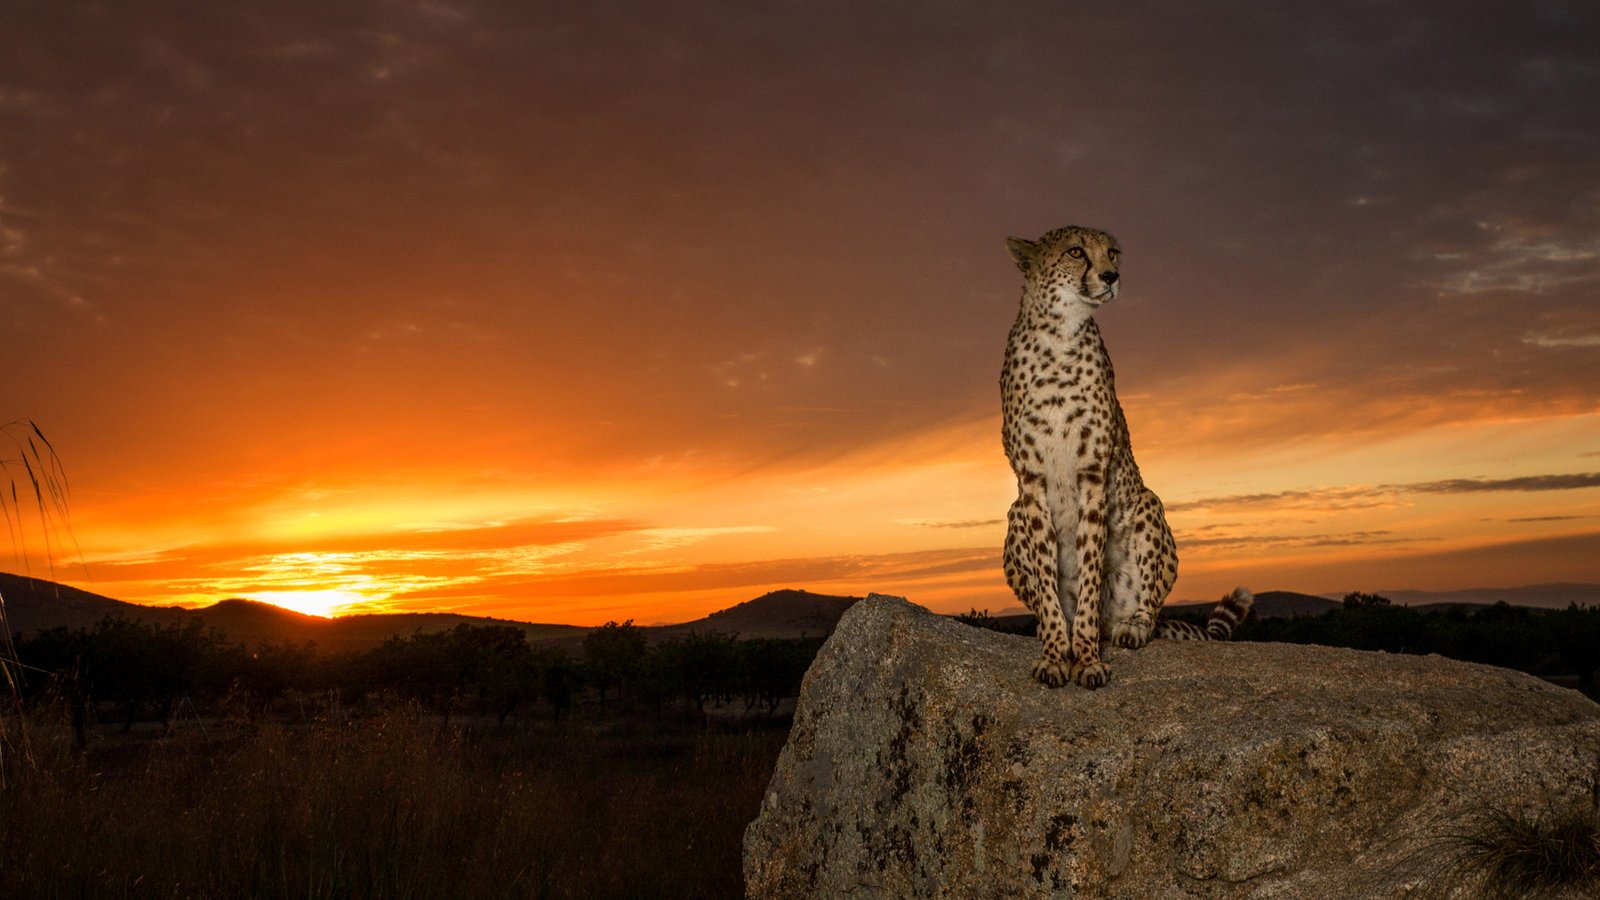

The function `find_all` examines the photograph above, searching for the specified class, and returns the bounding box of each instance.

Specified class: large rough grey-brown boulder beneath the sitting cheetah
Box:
[744,596,1600,900]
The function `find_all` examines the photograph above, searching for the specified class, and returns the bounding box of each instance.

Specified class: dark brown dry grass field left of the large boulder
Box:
[0,711,787,898]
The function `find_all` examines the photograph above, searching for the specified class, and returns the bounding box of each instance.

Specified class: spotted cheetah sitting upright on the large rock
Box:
[1000,226,1254,689]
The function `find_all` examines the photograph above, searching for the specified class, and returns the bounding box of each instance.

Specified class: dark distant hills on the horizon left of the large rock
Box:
[0,572,859,650]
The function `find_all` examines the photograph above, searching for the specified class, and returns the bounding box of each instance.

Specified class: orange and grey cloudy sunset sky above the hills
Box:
[0,0,1600,625]
